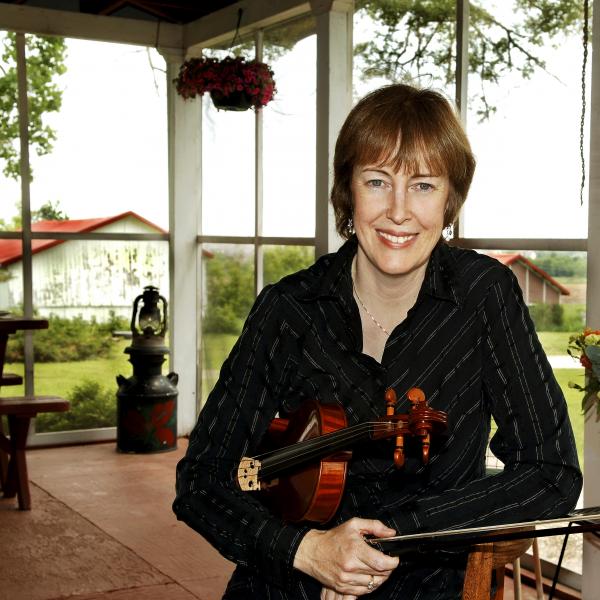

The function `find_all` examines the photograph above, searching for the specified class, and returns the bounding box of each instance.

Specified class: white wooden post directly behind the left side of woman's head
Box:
[310,0,354,257]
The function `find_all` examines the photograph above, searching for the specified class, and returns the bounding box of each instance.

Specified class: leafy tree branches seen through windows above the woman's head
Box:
[355,0,583,119]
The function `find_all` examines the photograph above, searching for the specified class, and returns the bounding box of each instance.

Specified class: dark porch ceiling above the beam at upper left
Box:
[0,0,236,25]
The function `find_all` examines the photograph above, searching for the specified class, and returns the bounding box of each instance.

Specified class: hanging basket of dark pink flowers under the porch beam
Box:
[174,56,276,110]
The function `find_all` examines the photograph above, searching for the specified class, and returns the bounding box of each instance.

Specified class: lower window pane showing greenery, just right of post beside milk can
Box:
[201,244,254,401]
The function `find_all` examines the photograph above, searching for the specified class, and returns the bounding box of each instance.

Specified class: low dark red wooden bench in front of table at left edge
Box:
[0,396,70,510]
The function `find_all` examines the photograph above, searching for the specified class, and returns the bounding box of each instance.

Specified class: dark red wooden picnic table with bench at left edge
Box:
[0,316,69,510]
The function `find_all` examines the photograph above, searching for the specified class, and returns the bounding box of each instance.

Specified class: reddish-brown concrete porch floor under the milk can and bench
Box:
[0,439,580,600]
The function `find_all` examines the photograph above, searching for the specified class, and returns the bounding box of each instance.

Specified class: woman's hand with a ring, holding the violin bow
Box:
[294,518,399,600]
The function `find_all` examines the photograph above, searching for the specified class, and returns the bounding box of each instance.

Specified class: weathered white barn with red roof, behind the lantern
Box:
[0,211,169,321]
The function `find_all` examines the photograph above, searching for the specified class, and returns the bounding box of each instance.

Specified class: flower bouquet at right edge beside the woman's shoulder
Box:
[567,329,600,420]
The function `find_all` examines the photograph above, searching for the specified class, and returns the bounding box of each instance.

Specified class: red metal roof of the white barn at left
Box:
[0,211,167,267]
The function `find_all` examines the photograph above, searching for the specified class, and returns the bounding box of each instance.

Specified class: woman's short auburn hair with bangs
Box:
[331,83,475,239]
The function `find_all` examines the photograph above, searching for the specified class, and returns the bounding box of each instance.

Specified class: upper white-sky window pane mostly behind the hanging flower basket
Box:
[202,47,255,236]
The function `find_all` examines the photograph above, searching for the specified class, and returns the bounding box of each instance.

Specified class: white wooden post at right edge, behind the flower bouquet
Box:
[582,0,600,600]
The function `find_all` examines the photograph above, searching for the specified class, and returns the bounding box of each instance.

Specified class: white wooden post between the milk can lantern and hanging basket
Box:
[163,52,202,435]
